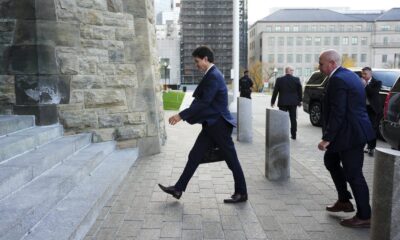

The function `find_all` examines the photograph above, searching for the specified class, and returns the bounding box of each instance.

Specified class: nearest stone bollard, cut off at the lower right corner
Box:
[371,148,400,240]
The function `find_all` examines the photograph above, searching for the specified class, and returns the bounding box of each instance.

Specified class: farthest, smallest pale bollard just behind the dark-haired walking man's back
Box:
[237,97,253,143]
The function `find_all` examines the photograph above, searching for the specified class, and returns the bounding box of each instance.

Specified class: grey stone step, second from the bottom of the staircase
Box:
[0,142,115,240]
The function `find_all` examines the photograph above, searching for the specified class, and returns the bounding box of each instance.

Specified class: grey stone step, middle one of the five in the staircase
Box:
[0,133,92,199]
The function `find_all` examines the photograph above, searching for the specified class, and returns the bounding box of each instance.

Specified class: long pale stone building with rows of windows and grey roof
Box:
[248,8,400,83]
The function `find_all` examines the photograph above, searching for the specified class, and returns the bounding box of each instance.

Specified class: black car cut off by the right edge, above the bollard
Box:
[380,78,400,150]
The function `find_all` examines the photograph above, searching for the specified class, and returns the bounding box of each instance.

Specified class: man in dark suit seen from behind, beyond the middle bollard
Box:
[271,67,302,139]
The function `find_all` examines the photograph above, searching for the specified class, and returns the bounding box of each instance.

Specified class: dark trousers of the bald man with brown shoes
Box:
[324,145,371,219]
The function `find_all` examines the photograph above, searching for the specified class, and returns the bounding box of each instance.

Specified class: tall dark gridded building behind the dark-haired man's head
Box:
[180,0,247,84]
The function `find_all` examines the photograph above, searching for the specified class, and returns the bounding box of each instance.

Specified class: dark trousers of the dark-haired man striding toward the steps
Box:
[175,117,247,194]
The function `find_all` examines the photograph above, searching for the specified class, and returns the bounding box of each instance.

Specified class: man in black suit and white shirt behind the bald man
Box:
[361,67,383,157]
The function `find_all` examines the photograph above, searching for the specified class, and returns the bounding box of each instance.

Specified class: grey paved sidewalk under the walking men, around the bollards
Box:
[85,94,382,240]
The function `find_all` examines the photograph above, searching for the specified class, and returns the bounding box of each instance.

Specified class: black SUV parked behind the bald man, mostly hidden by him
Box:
[303,69,400,126]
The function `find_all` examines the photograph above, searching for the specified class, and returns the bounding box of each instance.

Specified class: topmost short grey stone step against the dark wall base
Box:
[0,115,35,137]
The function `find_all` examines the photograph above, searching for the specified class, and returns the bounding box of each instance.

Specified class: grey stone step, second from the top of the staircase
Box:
[0,124,63,163]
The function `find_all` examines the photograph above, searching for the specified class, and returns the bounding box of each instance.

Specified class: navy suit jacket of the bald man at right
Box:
[322,67,375,152]
